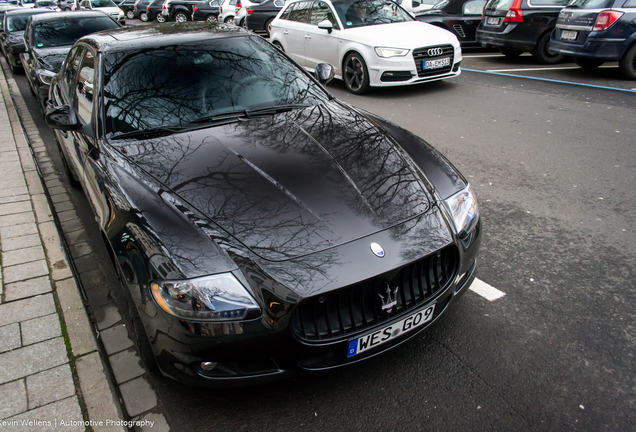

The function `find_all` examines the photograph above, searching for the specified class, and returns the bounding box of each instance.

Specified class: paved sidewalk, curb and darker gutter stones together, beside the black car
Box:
[0,55,170,432]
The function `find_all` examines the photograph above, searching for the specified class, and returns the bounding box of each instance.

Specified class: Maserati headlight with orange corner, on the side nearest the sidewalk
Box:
[151,273,260,321]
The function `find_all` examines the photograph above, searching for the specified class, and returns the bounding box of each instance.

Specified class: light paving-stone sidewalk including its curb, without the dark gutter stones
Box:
[0,64,127,432]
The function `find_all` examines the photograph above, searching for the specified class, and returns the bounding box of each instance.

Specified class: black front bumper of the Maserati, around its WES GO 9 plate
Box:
[142,219,481,388]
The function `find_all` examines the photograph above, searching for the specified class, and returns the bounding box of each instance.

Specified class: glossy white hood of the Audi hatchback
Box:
[340,21,459,49]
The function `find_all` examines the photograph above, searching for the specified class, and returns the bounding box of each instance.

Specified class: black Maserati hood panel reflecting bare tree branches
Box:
[111,101,438,261]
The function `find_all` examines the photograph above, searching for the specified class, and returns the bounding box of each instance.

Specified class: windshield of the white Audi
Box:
[333,0,414,29]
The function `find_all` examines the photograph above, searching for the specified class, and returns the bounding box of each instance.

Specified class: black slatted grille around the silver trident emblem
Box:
[292,246,458,342]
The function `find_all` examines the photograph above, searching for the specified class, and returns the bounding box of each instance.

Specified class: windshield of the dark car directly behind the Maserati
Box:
[31,15,119,48]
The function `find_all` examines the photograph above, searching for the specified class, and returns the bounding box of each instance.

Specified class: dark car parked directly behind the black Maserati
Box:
[20,11,120,110]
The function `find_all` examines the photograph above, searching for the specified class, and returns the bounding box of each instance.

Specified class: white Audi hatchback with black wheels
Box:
[271,0,462,94]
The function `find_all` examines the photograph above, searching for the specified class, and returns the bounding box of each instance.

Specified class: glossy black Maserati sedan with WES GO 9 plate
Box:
[46,23,480,386]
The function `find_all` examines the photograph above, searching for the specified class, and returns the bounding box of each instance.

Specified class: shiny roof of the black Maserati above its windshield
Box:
[79,22,253,53]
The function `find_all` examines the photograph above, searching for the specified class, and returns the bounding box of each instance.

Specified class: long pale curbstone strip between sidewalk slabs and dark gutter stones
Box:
[0,59,127,432]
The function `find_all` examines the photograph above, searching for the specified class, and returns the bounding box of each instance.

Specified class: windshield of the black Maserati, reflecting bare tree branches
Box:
[104,36,329,137]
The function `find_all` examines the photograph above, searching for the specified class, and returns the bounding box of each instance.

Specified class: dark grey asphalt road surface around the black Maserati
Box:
[6,45,636,431]
